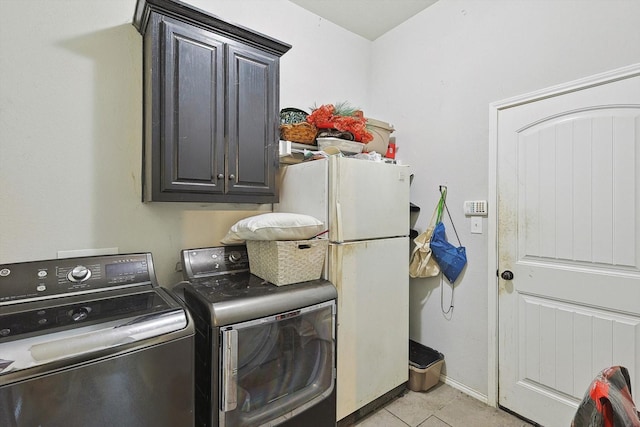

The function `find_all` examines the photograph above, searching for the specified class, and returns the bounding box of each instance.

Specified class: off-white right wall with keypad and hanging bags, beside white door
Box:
[371,0,640,398]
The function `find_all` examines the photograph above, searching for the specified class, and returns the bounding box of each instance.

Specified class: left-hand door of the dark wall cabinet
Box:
[153,19,226,200]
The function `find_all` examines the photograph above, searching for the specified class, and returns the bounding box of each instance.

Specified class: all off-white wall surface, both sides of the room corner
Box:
[0,0,640,397]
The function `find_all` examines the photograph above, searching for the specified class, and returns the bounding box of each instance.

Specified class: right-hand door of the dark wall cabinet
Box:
[227,44,279,202]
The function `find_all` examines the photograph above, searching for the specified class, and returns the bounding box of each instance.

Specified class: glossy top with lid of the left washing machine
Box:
[0,289,193,378]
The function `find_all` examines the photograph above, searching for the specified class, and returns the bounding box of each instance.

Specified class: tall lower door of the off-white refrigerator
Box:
[329,237,409,421]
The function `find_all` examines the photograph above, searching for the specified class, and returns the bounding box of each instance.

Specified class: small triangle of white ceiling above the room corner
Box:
[289,0,438,40]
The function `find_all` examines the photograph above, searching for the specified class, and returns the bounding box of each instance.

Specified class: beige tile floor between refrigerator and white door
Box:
[355,383,531,427]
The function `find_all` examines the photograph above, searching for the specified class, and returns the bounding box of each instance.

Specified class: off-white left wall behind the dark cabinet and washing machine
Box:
[0,0,370,284]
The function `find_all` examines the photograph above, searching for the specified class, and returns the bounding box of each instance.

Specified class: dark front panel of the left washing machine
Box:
[0,338,194,427]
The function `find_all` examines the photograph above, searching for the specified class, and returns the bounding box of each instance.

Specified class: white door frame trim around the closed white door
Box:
[487,63,640,407]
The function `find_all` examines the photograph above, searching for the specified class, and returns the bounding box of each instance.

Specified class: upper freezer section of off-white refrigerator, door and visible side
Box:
[275,156,410,242]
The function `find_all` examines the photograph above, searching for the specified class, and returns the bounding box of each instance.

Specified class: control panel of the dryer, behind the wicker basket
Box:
[182,245,249,280]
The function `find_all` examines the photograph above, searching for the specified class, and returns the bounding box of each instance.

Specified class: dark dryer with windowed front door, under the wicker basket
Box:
[174,247,337,427]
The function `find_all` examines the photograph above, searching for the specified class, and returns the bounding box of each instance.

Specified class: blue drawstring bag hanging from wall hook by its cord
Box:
[430,187,467,284]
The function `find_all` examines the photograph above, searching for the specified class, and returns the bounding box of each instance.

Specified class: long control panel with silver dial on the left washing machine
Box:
[0,253,155,305]
